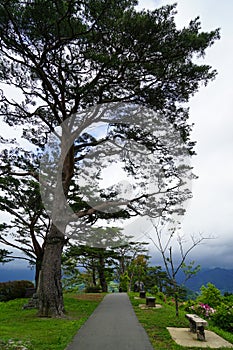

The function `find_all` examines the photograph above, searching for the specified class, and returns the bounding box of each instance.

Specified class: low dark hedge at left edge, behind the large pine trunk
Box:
[0,280,34,301]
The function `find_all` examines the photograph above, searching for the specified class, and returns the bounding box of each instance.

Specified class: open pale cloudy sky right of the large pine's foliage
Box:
[139,0,233,268]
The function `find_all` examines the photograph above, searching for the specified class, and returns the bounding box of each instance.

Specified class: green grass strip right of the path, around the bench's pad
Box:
[129,293,233,350]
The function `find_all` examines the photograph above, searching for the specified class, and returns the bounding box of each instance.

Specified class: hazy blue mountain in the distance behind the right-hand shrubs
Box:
[177,267,233,293]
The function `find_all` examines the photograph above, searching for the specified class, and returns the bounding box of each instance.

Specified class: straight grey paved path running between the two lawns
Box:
[66,293,153,350]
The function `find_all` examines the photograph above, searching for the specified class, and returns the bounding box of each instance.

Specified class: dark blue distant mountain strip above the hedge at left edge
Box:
[0,266,35,282]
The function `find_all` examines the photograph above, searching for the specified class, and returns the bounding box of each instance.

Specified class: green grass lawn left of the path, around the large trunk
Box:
[0,294,104,350]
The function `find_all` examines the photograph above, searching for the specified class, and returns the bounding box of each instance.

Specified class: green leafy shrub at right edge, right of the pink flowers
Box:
[212,303,233,332]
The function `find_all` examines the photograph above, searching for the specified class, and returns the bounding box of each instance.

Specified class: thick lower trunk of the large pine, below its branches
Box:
[38,225,64,317]
